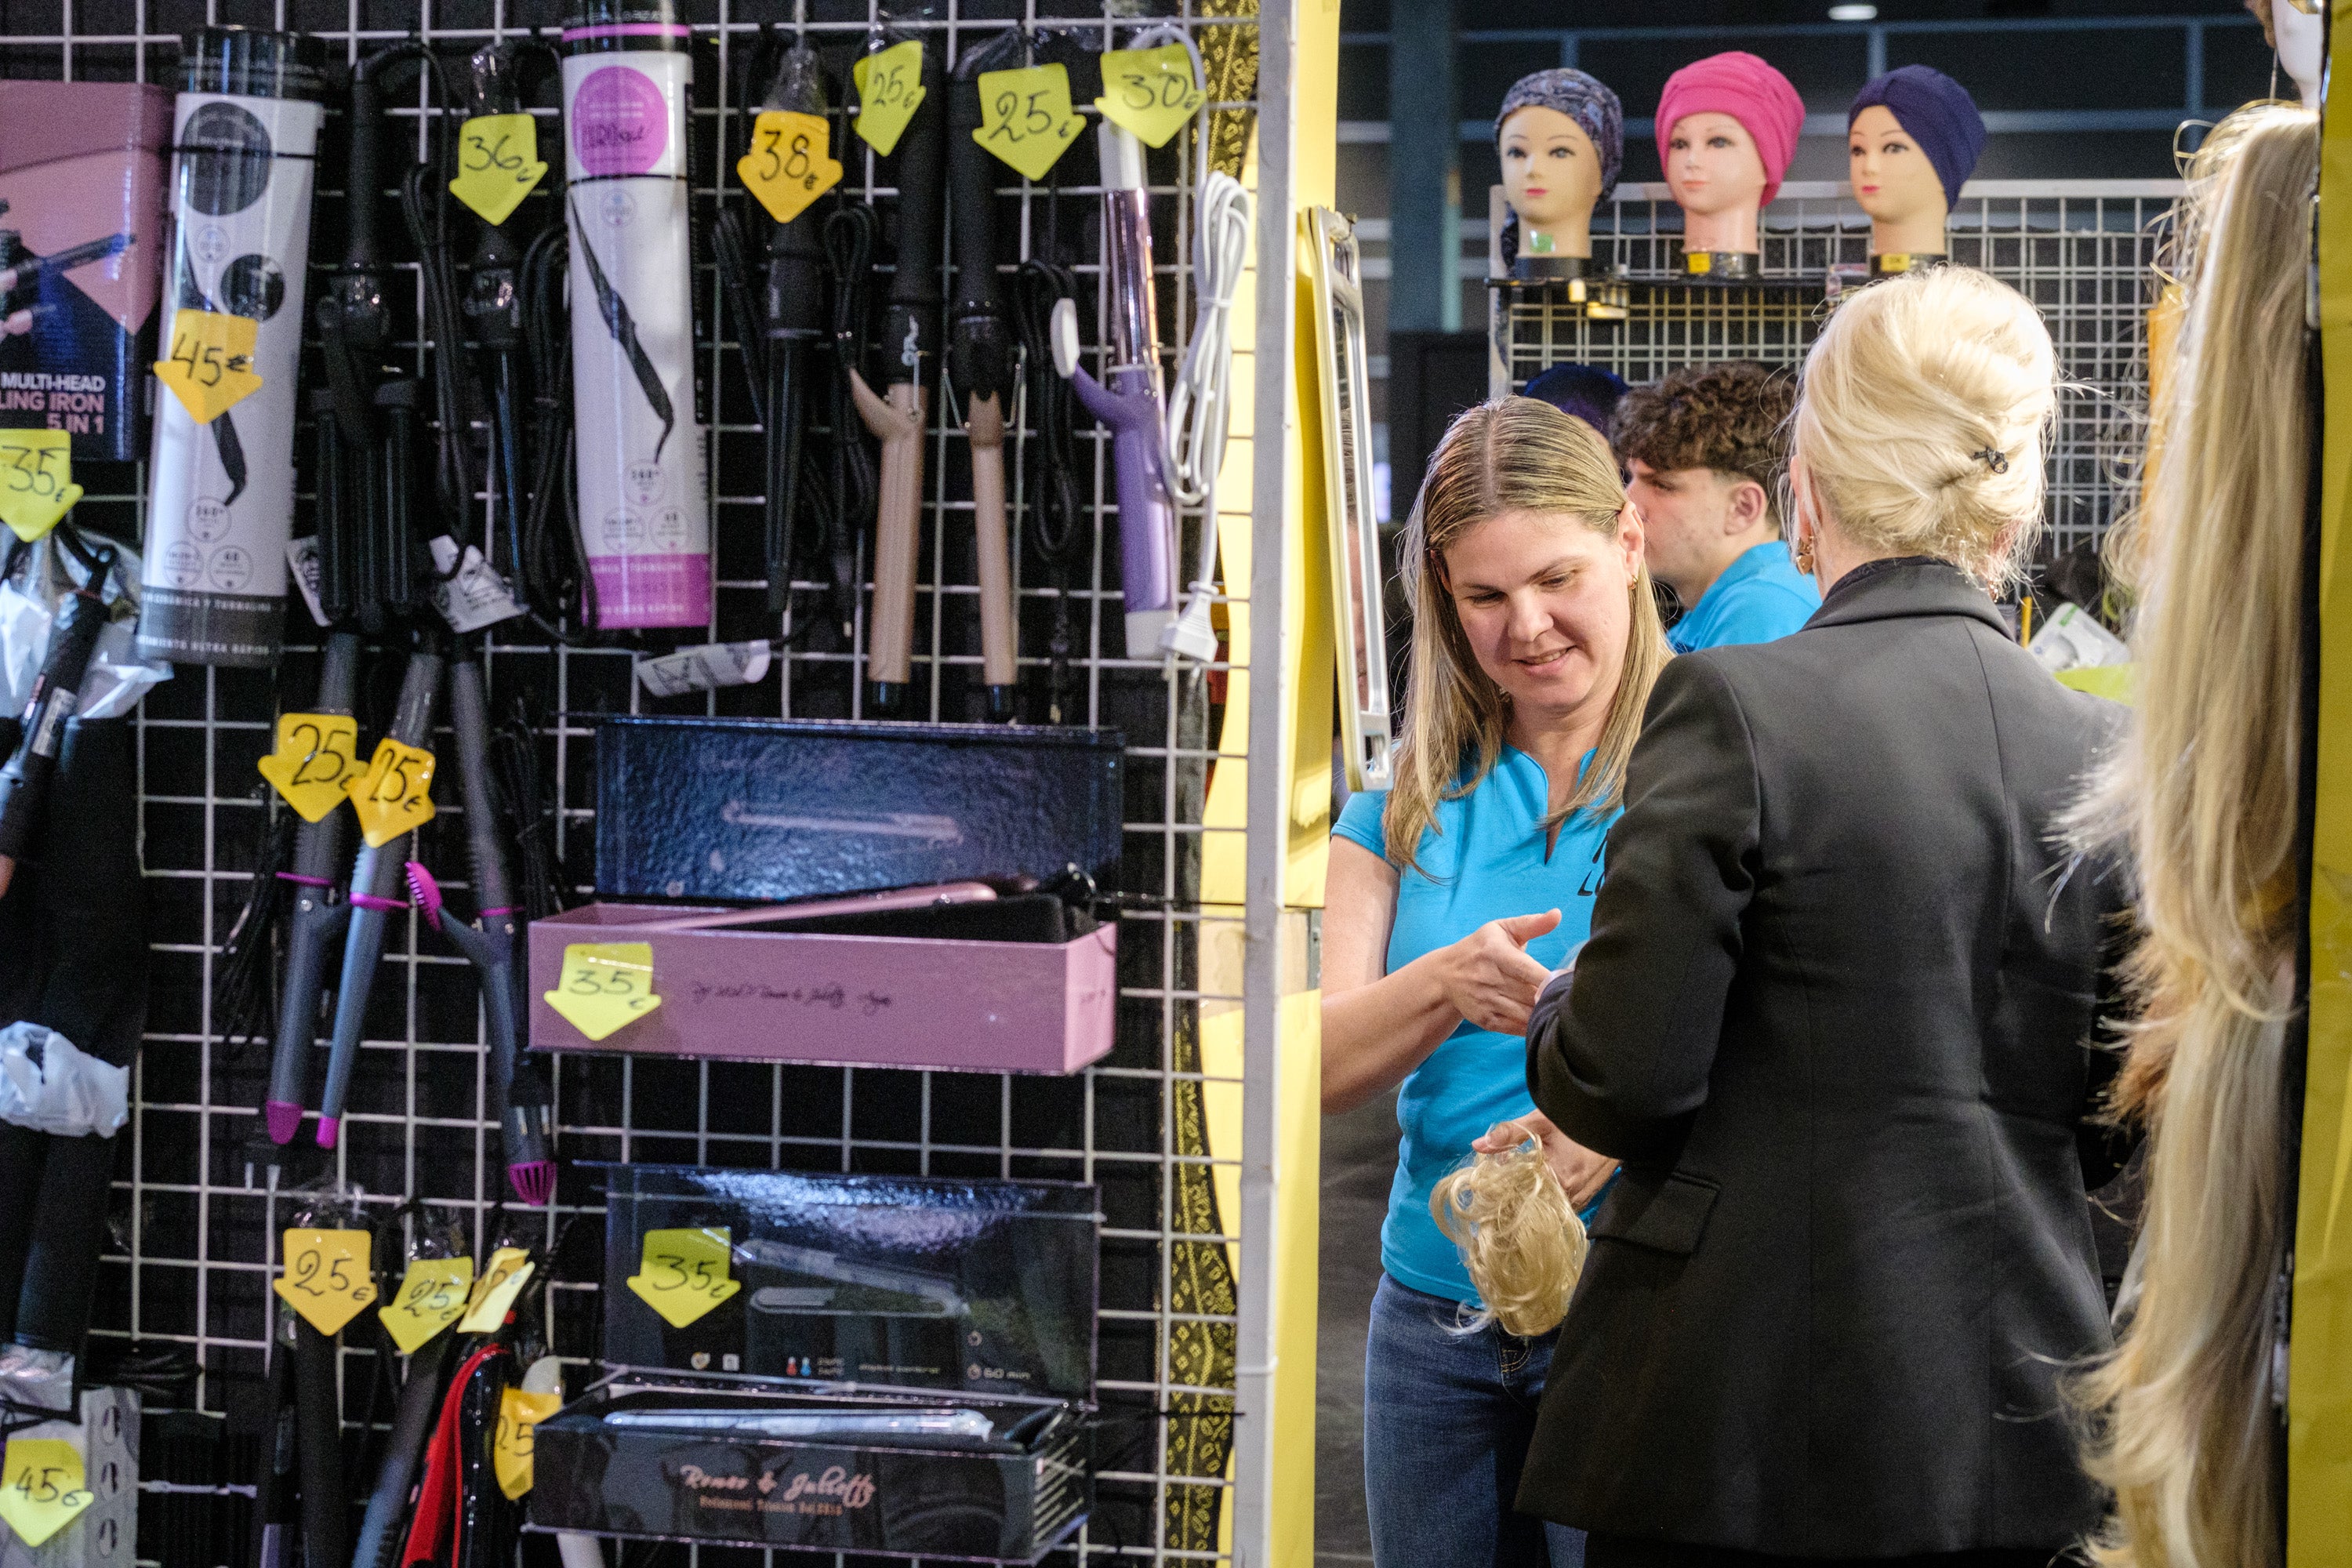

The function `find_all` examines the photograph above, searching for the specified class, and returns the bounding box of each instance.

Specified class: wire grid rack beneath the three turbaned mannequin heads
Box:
[1489,181,2180,550]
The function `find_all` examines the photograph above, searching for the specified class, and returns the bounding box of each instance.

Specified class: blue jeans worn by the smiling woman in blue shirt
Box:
[1364,1274,1585,1568]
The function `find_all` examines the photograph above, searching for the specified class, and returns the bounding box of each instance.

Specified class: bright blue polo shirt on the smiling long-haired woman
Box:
[1331,746,1618,1302]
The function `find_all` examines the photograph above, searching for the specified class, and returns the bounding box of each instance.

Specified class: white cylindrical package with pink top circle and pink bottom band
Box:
[564,0,710,630]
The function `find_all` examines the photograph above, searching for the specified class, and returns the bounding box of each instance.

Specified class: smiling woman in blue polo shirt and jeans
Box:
[1322,397,1668,1568]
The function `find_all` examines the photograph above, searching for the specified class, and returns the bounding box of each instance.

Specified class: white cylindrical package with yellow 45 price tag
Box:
[139,28,325,666]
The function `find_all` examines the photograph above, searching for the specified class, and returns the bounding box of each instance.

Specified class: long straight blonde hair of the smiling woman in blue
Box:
[1381,397,1670,869]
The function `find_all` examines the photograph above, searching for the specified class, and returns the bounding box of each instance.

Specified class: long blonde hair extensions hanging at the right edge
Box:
[2074,103,2319,1568]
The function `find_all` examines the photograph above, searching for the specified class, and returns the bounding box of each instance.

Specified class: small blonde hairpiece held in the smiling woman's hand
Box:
[1430,1138,1585,1340]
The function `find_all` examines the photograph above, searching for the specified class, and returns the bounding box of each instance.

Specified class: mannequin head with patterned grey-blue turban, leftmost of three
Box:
[1494,68,1625,256]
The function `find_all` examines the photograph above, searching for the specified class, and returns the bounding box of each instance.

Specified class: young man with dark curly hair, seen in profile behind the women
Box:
[1611,362,1820,654]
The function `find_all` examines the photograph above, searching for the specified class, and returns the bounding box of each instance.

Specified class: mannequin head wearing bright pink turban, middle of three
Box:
[1658,49,1804,270]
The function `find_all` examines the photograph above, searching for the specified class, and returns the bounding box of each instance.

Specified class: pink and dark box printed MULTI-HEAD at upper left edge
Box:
[0,82,172,463]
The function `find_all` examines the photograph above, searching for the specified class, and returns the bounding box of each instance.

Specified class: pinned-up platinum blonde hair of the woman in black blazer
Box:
[1792,266,2058,590]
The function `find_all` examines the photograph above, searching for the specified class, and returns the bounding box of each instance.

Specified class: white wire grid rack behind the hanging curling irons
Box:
[0,0,1256,1568]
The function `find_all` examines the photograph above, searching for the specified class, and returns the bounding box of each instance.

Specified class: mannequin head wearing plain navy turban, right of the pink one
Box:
[1846,66,1985,256]
